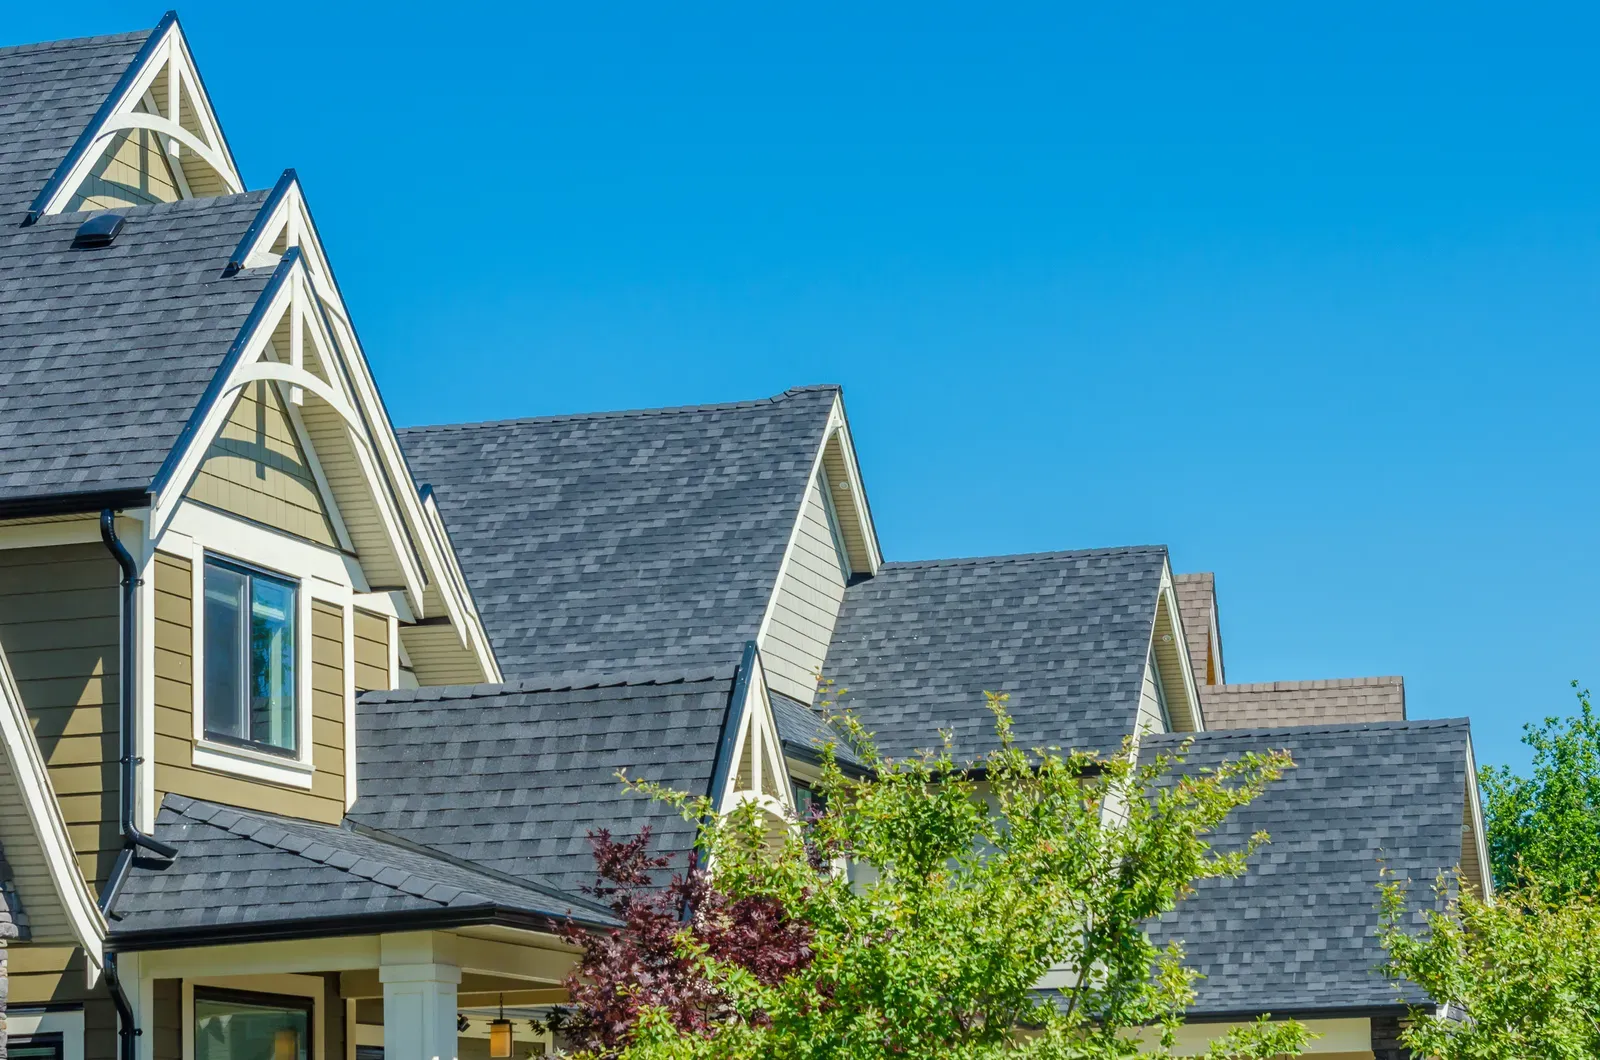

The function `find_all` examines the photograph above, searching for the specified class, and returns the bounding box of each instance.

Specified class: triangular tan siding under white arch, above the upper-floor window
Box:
[187,381,338,546]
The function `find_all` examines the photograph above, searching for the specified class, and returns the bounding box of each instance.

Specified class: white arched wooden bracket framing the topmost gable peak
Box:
[24,11,245,224]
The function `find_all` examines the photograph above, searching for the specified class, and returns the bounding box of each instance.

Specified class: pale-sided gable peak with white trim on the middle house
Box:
[757,395,883,703]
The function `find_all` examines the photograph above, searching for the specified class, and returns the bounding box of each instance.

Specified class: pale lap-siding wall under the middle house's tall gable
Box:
[760,477,845,703]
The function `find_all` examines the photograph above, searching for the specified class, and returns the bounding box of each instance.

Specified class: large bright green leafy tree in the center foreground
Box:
[579,697,1309,1060]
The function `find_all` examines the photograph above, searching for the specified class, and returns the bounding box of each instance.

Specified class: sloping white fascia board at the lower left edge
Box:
[0,634,106,983]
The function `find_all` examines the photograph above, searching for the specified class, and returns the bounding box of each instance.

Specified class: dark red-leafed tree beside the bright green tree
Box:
[563,826,811,1055]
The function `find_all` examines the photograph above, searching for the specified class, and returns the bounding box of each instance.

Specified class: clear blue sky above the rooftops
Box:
[15,0,1600,778]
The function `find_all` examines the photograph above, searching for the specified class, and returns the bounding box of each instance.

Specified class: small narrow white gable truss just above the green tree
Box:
[710,640,795,841]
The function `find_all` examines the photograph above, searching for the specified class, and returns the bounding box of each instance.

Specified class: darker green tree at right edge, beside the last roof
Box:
[1480,681,1600,897]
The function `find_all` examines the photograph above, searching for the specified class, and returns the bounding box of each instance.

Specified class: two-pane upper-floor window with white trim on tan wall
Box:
[202,557,299,757]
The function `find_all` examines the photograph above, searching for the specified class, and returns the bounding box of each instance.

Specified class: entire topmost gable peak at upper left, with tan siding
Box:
[27,11,245,223]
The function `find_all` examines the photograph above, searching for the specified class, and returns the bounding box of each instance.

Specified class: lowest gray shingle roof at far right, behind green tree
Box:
[1139,719,1470,1015]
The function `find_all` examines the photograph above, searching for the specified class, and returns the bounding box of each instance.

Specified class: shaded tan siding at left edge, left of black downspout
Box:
[0,544,122,887]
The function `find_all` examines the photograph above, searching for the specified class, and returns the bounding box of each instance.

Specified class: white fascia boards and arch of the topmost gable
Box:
[30,18,245,216]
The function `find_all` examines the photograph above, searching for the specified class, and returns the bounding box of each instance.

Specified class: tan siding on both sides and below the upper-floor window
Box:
[155,552,344,823]
